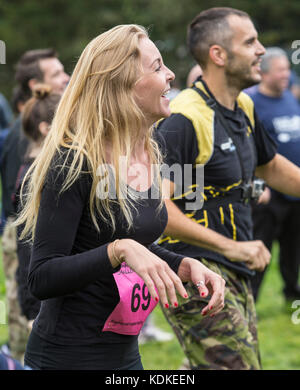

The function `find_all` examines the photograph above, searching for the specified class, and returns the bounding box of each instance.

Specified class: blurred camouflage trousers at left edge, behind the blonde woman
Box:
[2,219,29,363]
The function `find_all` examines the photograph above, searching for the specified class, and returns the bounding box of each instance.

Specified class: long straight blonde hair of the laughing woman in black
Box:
[16,25,162,238]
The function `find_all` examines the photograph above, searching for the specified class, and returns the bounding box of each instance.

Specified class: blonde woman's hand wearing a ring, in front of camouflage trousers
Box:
[178,257,225,316]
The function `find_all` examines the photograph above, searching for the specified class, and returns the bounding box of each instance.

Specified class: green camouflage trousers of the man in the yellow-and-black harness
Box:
[162,259,261,370]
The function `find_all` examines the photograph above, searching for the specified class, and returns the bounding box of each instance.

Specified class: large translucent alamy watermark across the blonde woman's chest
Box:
[96,156,204,210]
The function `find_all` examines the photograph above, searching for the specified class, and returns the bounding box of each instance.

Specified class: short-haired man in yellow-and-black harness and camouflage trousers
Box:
[156,8,300,370]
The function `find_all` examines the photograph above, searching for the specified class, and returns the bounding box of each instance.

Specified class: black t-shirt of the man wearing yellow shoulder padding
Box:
[157,82,276,275]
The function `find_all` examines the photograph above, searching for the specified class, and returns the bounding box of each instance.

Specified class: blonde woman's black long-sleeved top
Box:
[28,150,184,348]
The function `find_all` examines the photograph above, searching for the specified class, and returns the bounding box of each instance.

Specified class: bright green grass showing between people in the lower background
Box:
[0,239,300,370]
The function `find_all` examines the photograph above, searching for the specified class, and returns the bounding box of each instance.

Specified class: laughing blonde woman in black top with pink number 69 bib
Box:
[17,25,224,370]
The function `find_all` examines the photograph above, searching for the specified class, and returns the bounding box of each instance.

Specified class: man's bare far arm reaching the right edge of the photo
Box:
[255,153,300,197]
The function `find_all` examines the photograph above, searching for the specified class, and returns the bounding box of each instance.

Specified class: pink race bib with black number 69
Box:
[102,263,157,335]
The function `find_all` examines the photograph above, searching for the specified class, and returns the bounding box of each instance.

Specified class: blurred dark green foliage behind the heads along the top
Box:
[0,0,300,99]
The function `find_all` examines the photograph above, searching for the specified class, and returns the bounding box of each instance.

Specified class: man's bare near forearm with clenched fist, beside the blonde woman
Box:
[163,179,271,270]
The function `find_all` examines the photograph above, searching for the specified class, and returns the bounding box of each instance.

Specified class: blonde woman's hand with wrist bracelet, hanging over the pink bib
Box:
[107,238,188,308]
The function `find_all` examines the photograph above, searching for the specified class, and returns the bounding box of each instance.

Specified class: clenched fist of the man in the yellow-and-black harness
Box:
[223,240,271,271]
